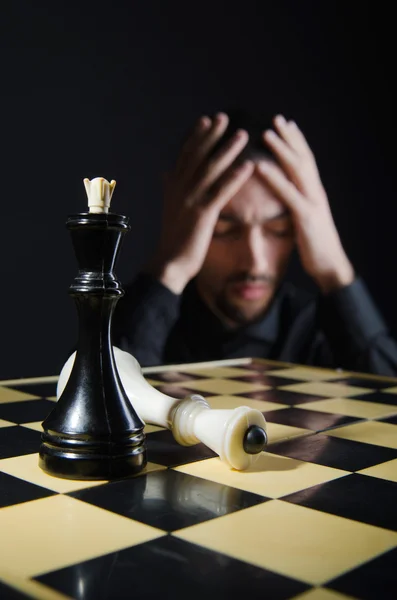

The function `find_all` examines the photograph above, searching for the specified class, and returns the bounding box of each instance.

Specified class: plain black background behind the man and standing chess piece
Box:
[0,0,397,378]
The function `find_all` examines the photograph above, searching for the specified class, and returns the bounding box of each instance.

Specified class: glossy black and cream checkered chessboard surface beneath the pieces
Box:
[0,359,397,600]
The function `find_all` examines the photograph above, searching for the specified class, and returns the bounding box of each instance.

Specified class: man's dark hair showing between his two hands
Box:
[211,108,275,163]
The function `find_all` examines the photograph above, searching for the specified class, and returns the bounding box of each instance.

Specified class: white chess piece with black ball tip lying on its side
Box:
[57,346,267,471]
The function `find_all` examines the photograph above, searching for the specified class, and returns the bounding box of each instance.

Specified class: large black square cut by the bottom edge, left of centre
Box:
[36,536,310,600]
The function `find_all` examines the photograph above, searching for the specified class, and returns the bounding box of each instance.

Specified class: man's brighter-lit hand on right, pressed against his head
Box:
[256,115,354,293]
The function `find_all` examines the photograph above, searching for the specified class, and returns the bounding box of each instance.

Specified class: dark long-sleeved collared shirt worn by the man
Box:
[113,273,397,376]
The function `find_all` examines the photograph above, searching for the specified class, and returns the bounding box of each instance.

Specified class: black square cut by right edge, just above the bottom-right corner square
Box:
[282,473,397,531]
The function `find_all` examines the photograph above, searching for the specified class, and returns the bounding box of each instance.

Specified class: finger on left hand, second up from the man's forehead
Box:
[193,130,248,200]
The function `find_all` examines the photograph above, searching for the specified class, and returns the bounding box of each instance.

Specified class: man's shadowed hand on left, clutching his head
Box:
[147,113,254,294]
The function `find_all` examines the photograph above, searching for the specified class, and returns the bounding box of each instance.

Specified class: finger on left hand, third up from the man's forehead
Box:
[176,113,229,181]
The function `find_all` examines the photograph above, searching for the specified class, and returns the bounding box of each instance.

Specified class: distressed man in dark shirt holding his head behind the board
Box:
[115,113,397,376]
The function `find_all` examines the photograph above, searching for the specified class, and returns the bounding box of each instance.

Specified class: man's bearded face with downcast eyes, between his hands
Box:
[197,169,294,326]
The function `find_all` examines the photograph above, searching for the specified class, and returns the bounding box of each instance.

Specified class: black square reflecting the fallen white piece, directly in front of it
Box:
[69,469,268,531]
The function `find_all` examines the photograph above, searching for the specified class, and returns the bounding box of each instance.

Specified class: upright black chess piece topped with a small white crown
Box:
[39,177,146,480]
